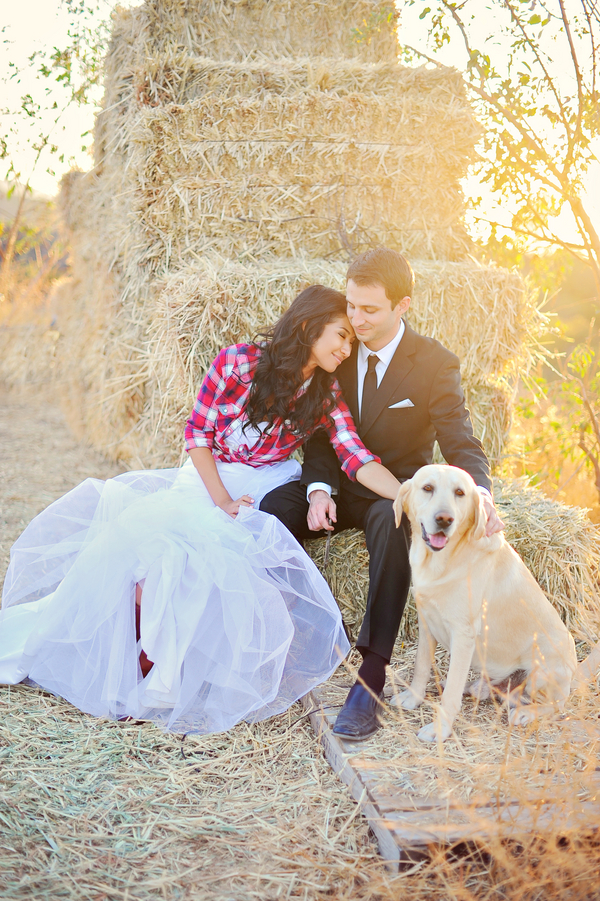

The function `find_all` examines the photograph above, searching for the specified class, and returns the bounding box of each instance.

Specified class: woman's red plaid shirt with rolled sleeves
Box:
[185,344,381,479]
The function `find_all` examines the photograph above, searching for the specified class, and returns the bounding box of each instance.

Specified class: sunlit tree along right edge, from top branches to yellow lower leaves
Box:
[399,0,600,500]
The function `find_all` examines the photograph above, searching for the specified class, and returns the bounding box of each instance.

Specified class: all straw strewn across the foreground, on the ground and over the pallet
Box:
[0,672,600,901]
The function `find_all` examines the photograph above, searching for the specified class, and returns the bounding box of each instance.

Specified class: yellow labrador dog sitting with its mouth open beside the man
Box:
[392,466,589,741]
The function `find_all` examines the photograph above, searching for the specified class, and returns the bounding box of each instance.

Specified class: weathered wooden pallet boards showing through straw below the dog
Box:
[303,686,600,869]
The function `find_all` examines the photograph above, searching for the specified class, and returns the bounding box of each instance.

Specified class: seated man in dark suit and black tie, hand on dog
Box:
[260,247,503,740]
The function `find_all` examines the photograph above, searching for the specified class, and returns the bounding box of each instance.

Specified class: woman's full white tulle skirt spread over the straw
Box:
[0,460,349,733]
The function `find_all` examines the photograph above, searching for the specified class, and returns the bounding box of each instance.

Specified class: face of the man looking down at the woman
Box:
[346,278,410,351]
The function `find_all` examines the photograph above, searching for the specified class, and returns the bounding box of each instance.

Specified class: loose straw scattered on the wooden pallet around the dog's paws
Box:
[320,643,600,804]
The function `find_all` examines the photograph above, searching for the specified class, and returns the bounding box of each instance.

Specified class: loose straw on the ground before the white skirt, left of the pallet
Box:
[0,686,380,899]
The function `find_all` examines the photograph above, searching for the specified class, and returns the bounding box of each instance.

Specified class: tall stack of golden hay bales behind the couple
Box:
[58,0,596,640]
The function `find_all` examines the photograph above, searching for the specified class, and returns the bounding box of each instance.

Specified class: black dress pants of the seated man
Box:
[260,482,410,660]
